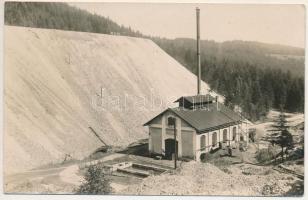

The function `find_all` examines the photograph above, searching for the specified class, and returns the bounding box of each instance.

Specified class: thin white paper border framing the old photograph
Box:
[0,0,308,200]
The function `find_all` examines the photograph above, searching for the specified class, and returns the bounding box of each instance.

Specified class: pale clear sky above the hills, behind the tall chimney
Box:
[70,2,305,48]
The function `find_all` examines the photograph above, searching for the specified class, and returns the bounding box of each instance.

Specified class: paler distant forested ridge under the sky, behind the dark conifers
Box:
[153,38,305,76]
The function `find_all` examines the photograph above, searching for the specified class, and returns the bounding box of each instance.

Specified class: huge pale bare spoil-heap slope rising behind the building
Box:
[4,26,217,173]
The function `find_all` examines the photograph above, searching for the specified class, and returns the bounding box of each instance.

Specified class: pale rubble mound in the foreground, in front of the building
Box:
[121,154,300,196]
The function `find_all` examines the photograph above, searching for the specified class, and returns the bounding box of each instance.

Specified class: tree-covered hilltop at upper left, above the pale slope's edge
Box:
[4,2,142,37]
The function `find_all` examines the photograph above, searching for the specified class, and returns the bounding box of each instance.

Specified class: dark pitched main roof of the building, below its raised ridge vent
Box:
[144,103,241,133]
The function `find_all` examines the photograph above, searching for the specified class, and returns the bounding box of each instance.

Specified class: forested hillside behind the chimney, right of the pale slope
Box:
[154,38,305,121]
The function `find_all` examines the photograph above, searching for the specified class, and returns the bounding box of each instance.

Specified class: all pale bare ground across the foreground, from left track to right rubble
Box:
[5,112,304,196]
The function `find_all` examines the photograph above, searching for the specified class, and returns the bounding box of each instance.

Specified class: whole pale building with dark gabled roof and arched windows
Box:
[145,95,248,161]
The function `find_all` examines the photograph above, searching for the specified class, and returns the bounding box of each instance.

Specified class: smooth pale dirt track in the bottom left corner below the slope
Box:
[4,153,124,194]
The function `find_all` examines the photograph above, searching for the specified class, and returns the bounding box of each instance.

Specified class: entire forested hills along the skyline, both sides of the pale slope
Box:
[5,2,304,120]
